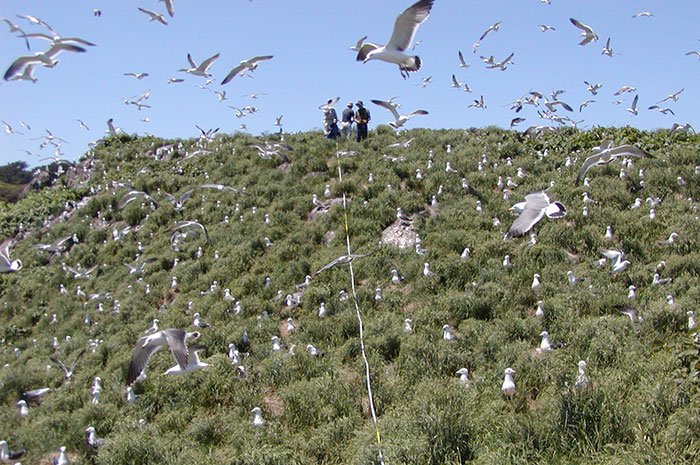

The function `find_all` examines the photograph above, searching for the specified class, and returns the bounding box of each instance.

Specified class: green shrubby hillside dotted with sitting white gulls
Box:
[0,127,700,465]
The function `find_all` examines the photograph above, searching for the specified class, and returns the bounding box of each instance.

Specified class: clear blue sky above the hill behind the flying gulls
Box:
[0,0,700,166]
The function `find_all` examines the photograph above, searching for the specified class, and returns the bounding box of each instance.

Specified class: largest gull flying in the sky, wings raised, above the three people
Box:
[356,0,435,78]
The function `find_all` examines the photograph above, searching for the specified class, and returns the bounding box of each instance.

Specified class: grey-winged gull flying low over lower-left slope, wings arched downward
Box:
[126,328,200,386]
